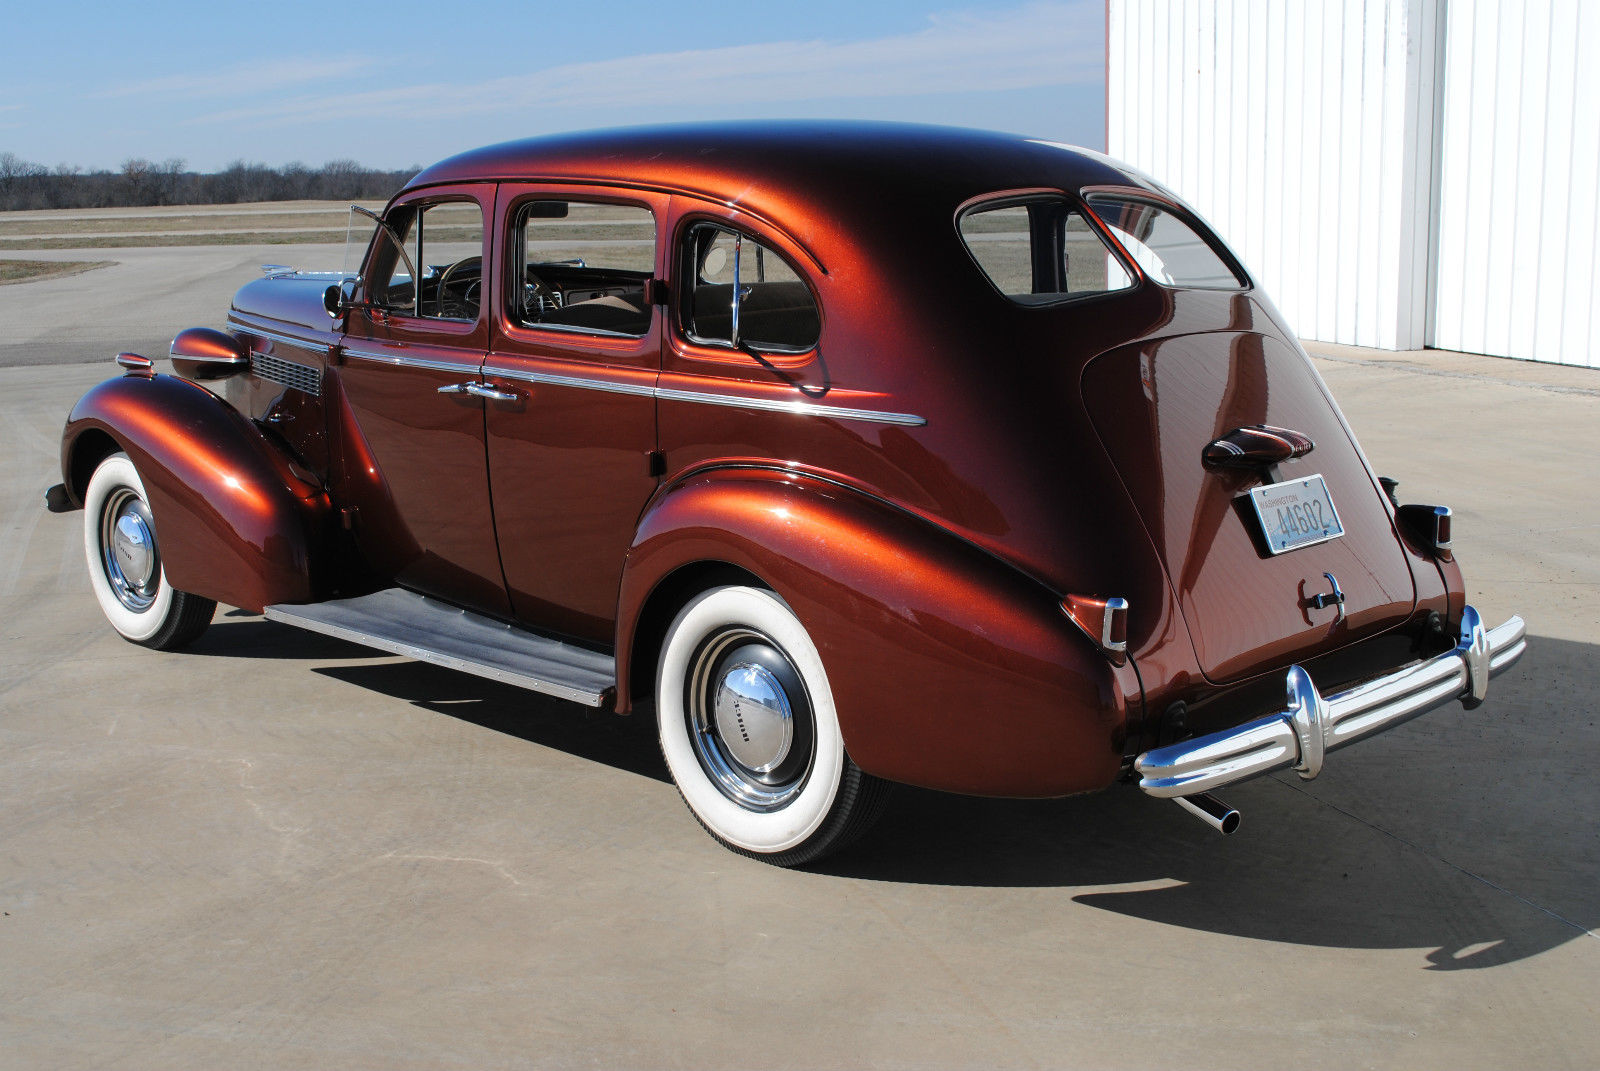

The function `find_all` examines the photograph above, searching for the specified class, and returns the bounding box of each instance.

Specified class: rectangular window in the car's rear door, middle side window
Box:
[509,200,656,338]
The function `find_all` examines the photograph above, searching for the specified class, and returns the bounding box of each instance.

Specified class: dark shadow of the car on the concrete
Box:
[208,608,1600,970]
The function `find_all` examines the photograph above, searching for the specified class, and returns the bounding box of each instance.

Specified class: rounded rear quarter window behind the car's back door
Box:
[683,223,822,354]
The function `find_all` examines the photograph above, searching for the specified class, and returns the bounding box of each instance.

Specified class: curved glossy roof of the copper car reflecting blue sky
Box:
[406,120,1147,215]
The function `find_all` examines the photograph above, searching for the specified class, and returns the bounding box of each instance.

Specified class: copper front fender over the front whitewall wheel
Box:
[61,375,328,612]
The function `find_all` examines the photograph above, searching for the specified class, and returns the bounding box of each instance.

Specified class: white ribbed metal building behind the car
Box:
[1106,0,1600,368]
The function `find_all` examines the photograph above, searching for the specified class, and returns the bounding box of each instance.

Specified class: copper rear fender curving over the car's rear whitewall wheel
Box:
[618,469,1141,796]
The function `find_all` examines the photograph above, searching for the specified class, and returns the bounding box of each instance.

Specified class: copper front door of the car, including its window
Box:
[339,184,510,616]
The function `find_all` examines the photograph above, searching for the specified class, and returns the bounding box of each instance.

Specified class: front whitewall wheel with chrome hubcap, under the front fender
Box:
[83,453,216,650]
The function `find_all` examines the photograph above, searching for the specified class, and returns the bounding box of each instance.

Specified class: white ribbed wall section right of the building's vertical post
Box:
[1430,0,1600,367]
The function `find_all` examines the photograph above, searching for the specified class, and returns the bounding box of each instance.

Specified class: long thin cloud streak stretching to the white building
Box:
[187,0,1104,125]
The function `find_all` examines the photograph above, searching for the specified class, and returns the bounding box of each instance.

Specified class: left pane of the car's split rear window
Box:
[957,195,1133,304]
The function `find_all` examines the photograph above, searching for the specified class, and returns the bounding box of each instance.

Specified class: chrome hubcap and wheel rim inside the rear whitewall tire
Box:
[683,629,816,812]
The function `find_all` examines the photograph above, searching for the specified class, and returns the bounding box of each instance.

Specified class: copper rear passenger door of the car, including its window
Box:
[483,183,667,644]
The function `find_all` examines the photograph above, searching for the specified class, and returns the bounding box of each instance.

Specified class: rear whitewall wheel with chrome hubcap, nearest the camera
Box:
[656,586,888,866]
